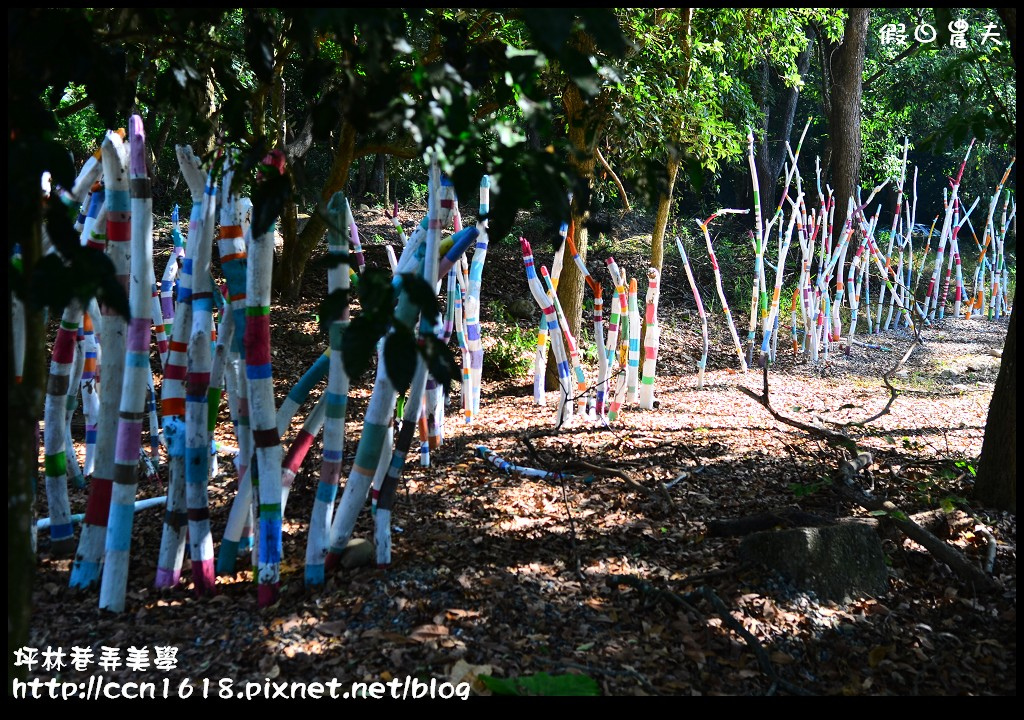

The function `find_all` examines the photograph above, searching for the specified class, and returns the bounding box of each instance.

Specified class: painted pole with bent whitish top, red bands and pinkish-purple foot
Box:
[154,145,206,588]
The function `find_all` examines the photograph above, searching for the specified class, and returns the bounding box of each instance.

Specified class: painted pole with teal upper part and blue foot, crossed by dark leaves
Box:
[305,193,351,585]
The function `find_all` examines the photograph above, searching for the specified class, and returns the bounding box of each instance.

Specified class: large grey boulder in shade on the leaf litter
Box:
[739,522,889,602]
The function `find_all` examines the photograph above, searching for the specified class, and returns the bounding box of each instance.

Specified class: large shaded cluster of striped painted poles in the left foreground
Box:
[40,126,489,610]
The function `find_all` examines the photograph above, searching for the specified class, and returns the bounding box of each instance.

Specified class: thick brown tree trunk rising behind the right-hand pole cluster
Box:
[819,7,871,240]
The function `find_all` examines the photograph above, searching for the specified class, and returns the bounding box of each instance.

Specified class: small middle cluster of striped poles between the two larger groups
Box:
[519,225,660,427]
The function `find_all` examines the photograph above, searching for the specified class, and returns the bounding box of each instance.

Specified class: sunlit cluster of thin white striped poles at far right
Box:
[667,131,1016,387]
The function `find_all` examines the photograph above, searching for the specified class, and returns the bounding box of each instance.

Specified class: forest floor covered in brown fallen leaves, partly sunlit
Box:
[31,203,1017,695]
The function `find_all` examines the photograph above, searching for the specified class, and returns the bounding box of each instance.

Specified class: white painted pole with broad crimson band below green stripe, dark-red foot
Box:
[244,151,285,607]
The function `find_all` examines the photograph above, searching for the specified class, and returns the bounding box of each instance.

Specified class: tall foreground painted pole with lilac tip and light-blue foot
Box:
[99,115,153,612]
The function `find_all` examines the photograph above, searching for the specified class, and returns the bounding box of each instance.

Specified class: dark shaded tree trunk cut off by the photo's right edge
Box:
[974,8,1019,514]
